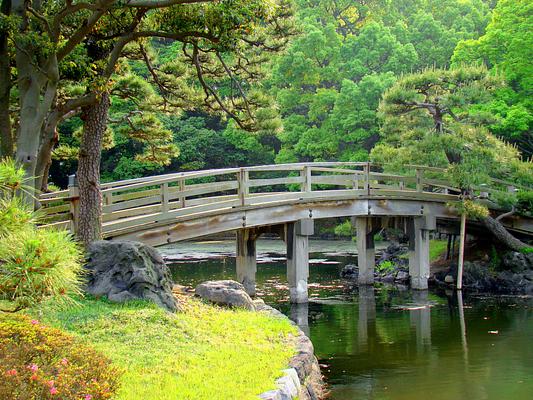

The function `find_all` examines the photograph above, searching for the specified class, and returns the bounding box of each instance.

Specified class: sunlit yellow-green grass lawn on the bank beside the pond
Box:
[34,299,296,400]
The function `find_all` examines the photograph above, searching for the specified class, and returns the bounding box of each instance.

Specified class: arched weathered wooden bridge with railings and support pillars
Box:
[40,162,533,302]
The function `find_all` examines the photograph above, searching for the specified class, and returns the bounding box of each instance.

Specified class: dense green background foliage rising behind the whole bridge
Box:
[38,0,532,200]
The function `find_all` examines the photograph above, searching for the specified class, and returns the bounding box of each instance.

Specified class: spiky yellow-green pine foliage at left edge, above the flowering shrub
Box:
[0,160,82,311]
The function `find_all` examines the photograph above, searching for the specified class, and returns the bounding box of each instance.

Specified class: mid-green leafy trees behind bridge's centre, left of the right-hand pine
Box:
[270,0,489,162]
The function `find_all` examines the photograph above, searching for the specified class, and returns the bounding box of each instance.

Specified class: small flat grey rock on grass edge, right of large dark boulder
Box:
[195,280,255,311]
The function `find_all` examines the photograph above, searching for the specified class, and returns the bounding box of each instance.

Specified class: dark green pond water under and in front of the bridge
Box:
[161,240,533,400]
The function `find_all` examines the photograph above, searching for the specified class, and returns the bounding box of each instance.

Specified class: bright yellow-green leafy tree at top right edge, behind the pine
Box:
[453,0,533,158]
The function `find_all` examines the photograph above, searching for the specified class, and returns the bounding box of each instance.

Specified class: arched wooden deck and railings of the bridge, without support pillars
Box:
[40,162,533,244]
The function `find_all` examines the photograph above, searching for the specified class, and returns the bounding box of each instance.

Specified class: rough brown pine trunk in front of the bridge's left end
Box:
[76,93,109,246]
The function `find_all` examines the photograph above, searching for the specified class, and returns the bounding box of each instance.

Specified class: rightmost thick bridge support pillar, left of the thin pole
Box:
[408,216,436,290]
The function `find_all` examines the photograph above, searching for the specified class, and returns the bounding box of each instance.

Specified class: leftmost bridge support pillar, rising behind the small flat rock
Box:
[236,229,257,296]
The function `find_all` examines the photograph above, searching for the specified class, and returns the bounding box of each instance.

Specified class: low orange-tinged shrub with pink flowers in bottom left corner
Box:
[0,314,120,400]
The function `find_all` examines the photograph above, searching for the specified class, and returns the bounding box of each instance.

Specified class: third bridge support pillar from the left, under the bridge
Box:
[355,217,376,285]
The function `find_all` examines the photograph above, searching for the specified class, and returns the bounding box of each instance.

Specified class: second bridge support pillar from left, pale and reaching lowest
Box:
[286,219,314,303]
